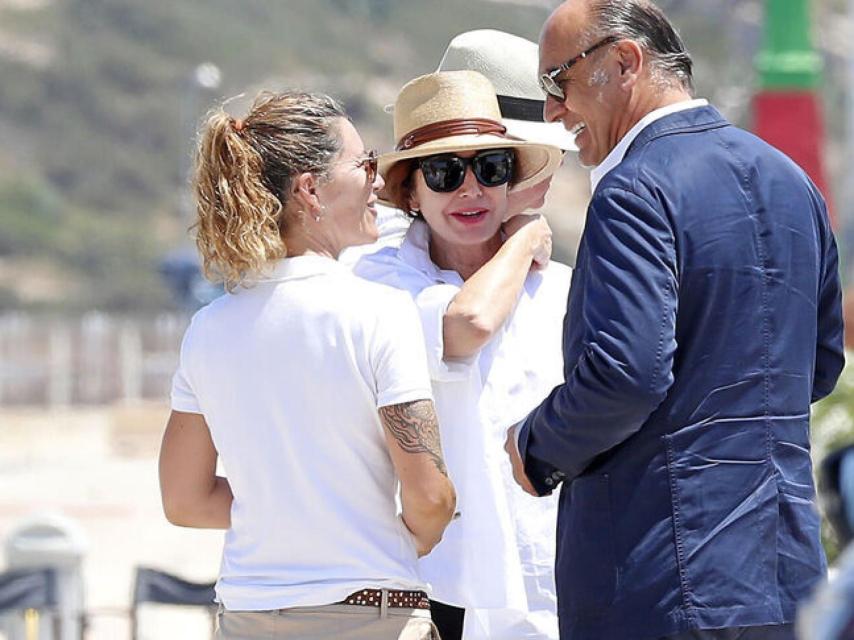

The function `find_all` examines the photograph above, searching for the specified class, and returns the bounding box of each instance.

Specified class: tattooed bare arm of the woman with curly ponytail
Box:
[379,400,457,556]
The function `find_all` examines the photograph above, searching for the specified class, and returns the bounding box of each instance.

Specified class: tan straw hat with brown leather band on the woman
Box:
[379,71,561,198]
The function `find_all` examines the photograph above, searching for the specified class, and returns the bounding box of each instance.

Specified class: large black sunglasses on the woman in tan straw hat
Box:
[418,149,516,193]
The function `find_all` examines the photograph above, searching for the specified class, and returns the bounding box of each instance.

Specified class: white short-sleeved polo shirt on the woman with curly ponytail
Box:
[172,256,431,611]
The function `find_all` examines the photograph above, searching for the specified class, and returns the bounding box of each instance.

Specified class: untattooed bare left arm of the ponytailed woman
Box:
[160,411,233,529]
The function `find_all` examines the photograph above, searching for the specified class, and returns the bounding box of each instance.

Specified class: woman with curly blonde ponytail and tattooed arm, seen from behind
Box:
[160,93,455,640]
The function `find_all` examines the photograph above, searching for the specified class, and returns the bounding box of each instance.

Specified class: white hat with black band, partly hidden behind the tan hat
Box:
[437,29,578,151]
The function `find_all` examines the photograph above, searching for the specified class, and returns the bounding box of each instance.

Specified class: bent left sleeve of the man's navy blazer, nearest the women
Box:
[518,188,678,494]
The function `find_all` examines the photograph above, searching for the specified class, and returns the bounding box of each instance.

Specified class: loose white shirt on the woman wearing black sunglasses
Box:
[355,220,571,640]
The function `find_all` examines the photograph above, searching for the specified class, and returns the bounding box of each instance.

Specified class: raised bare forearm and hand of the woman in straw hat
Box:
[442,215,552,358]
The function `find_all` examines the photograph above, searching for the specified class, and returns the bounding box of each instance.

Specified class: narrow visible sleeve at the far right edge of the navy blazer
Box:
[812,194,845,402]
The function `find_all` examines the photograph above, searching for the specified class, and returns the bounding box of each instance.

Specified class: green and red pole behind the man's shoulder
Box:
[753,0,833,228]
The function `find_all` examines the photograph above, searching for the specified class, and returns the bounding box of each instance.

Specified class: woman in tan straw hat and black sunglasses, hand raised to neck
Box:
[356,71,570,640]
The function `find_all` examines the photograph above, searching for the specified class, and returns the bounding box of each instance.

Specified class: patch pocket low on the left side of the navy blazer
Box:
[556,475,617,618]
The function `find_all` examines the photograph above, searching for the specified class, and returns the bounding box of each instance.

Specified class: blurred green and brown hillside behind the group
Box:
[0,0,850,312]
